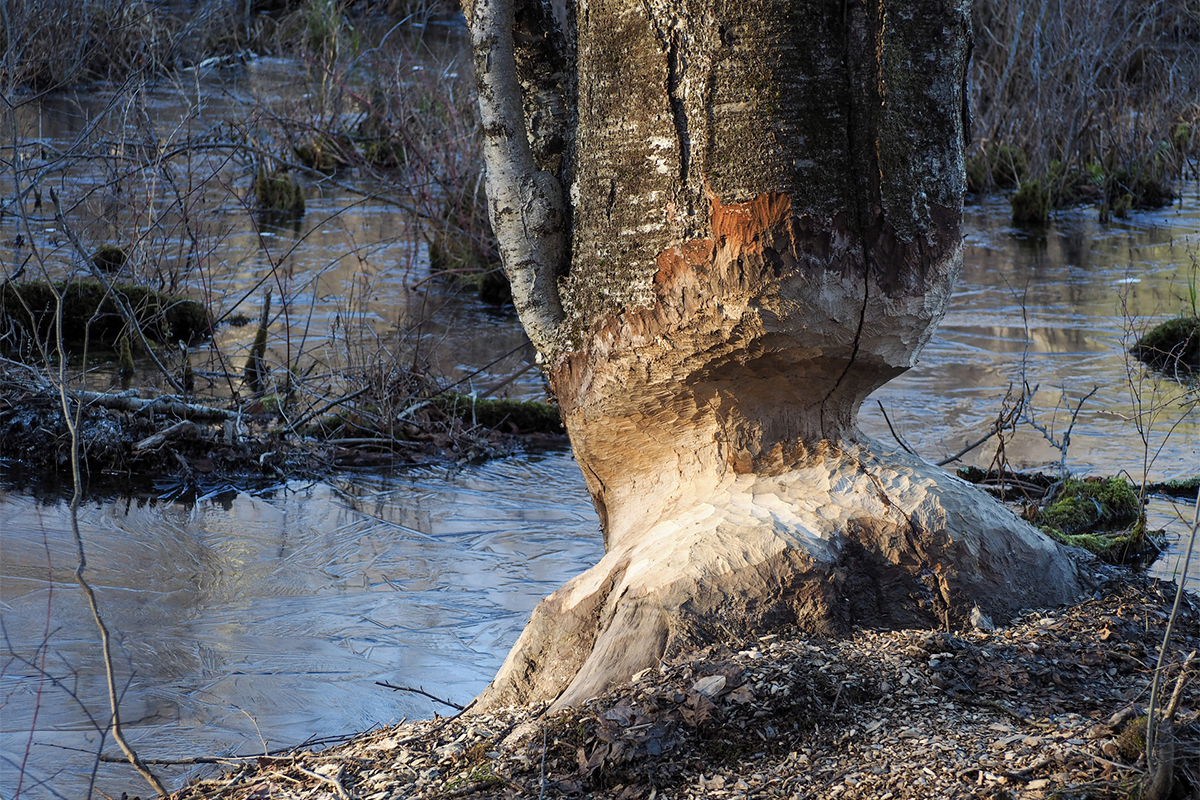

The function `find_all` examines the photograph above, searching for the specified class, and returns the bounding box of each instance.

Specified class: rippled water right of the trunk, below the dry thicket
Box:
[862,193,1200,480]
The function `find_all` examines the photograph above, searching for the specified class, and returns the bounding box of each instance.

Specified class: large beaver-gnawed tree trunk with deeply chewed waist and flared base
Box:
[468,0,1081,706]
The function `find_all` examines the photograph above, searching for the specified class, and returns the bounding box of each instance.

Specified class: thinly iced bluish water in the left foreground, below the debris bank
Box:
[0,452,601,798]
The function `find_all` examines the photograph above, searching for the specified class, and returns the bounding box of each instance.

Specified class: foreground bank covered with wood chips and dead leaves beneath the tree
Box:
[162,567,1200,800]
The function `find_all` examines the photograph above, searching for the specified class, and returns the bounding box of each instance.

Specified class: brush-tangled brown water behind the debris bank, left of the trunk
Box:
[0,38,545,397]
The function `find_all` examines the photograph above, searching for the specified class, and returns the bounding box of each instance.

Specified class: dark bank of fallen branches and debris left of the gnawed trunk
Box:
[0,362,566,488]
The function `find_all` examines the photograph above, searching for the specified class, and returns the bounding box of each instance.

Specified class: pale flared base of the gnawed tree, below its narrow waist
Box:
[476,443,1086,708]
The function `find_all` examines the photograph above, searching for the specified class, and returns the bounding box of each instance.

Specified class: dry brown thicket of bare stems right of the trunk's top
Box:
[970,0,1200,218]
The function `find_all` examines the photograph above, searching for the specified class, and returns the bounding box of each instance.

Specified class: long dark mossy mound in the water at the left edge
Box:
[0,281,212,348]
